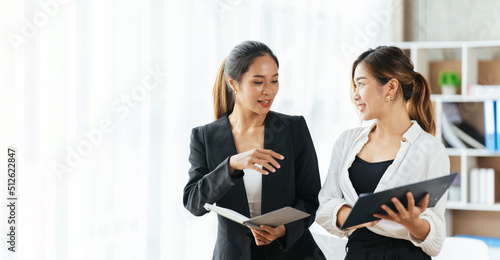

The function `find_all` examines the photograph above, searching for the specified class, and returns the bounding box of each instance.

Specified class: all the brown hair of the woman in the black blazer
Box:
[212,41,279,120]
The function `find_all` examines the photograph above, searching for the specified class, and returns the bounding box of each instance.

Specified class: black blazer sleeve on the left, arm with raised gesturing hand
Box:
[183,127,243,216]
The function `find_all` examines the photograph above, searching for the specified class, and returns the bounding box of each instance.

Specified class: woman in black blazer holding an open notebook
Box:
[183,41,325,260]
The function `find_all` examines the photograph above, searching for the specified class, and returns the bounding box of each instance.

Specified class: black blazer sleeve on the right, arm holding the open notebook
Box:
[279,116,321,250]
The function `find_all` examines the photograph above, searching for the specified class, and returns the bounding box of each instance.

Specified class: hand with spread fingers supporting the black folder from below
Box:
[373,192,430,240]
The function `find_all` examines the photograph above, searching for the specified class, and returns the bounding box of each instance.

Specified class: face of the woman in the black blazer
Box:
[228,55,279,115]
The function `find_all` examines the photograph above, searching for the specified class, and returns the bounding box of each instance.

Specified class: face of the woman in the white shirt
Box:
[353,62,390,121]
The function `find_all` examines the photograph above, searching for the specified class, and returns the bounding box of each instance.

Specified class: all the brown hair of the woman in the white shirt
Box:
[351,46,436,135]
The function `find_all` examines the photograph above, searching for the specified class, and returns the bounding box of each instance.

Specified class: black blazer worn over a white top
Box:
[183,111,325,260]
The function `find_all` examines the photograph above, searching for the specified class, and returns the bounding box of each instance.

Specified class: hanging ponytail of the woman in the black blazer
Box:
[213,57,234,120]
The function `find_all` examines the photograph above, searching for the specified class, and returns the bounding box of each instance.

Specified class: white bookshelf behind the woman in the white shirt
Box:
[387,40,500,238]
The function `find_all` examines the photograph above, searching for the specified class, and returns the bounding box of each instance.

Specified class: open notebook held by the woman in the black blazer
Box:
[204,203,310,230]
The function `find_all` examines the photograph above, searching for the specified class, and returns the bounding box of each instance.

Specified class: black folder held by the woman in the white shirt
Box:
[340,172,458,229]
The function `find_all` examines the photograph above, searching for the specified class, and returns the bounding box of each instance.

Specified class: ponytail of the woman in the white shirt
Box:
[407,72,436,135]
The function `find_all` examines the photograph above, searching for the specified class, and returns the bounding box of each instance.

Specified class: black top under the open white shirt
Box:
[349,155,394,195]
